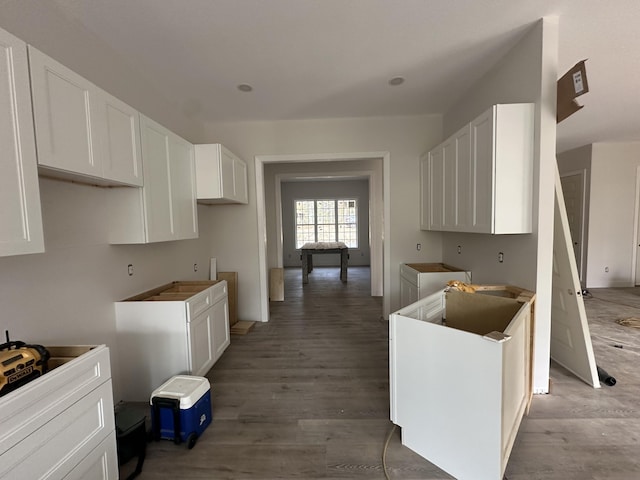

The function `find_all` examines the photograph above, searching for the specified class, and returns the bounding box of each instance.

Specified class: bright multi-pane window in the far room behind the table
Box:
[295,198,358,248]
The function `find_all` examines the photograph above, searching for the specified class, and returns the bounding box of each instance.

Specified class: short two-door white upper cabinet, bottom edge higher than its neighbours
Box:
[29,46,143,186]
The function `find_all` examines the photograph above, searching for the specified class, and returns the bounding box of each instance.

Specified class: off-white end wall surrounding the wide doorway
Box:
[205,115,442,320]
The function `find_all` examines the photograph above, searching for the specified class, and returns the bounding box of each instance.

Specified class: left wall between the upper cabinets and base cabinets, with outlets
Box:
[0,178,220,401]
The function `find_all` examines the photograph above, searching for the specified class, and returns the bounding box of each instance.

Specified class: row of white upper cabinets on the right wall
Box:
[420,103,534,234]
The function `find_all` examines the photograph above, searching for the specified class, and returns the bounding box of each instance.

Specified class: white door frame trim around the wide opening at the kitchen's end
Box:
[255,152,391,321]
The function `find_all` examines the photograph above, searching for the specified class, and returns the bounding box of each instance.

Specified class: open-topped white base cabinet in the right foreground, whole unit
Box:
[389,289,534,480]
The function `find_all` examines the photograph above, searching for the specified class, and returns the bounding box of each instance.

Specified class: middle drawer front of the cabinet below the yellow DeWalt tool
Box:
[0,381,115,480]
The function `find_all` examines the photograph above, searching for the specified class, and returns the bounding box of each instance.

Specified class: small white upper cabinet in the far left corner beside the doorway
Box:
[195,143,249,204]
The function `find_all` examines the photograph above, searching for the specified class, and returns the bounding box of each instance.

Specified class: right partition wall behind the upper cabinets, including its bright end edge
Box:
[443,19,558,393]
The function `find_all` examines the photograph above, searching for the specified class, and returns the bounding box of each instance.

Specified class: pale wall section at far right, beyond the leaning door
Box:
[587,142,640,288]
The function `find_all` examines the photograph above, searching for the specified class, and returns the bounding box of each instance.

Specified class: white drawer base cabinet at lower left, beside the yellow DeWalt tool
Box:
[0,345,118,480]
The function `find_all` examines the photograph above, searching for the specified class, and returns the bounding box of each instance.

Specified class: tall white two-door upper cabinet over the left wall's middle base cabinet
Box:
[109,115,198,244]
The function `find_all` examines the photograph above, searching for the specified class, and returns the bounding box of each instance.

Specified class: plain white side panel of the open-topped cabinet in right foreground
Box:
[392,315,503,479]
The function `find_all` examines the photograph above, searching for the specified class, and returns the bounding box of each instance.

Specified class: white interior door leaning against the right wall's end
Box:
[551,167,600,388]
